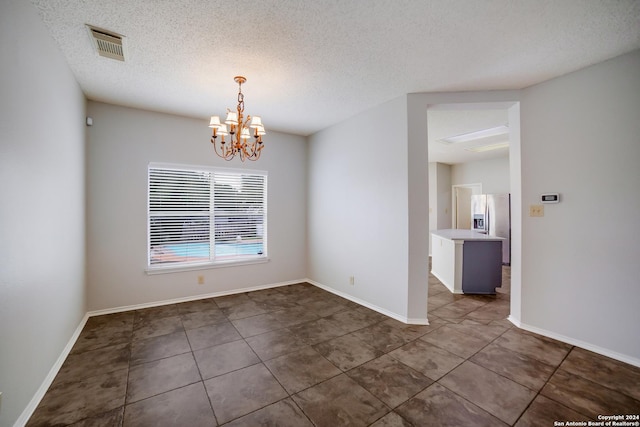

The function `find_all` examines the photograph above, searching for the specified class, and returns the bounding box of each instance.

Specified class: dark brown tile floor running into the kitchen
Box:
[28,268,640,427]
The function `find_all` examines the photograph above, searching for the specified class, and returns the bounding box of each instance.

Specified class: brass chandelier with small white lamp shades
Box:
[209,76,266,162]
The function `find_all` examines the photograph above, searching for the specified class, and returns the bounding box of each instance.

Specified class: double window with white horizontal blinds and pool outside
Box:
[148,164,267,270]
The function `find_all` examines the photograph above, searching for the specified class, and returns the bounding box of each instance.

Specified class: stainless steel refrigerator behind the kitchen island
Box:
[471,194,511,265]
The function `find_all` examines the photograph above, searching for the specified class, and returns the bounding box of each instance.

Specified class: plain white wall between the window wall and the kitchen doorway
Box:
[308,97,412,317]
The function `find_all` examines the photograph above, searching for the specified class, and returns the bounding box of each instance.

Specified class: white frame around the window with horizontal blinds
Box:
[145,162,269,274]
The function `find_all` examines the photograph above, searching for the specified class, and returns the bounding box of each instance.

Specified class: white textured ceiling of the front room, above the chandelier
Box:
[32,0,640,143]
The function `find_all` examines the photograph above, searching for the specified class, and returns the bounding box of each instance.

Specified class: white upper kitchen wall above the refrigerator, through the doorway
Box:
[451,155,511,194]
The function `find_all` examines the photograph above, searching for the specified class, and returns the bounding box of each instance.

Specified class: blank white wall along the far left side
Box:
[0,0,85,426]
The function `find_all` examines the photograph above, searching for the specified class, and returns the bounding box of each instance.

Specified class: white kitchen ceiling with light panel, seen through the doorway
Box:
[427,104,509,165]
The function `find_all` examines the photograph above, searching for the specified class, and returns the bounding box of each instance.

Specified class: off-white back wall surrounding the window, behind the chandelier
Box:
[87,102,307,311]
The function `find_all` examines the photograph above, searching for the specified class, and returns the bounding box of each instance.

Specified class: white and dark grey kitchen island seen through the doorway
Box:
[431,229,504,294]
